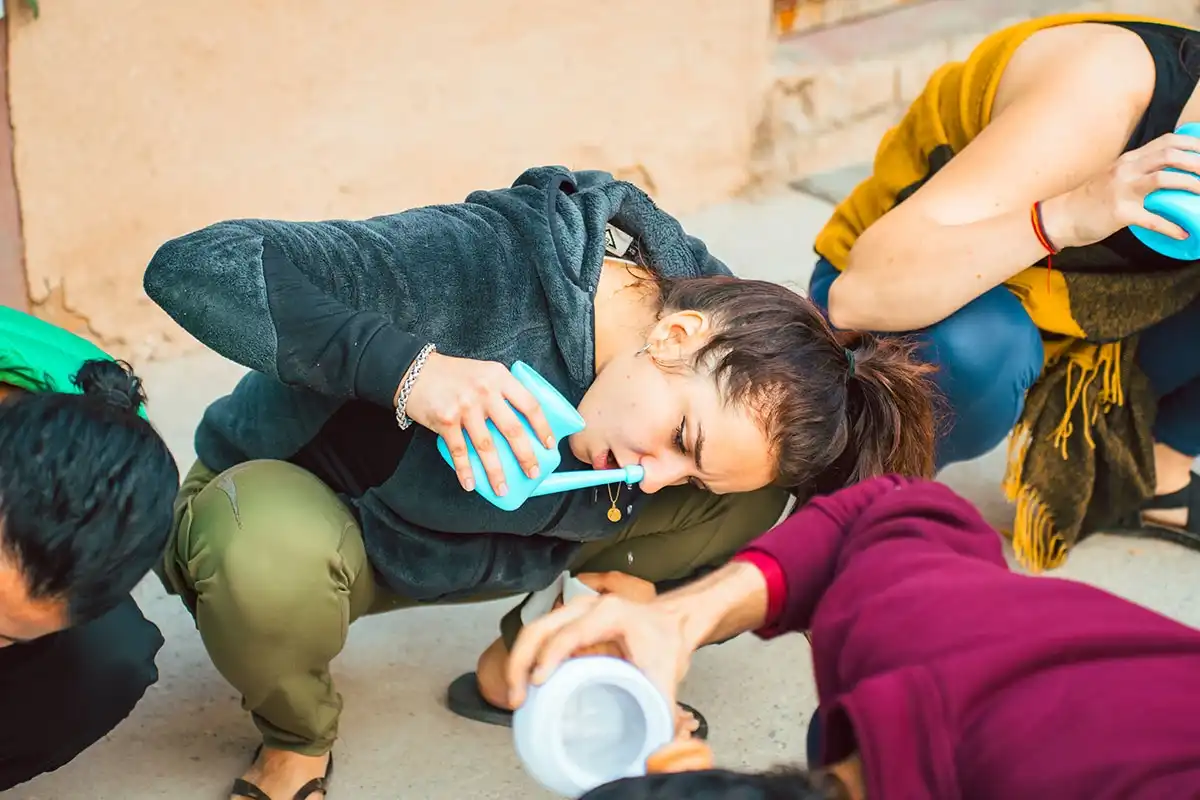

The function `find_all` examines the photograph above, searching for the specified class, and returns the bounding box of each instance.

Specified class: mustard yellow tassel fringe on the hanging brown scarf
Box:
[1002,342,1126,572]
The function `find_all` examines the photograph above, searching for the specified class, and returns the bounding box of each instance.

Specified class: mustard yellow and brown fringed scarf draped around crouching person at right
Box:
[816,13,1187,570]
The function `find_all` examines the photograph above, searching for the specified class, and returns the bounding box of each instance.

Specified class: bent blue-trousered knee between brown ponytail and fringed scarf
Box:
[917,287,1044,467]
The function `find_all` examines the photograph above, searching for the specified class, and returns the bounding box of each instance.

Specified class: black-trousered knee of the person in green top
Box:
[0,597,163,790]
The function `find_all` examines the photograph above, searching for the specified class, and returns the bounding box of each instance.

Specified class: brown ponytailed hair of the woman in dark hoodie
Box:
[656,276,935,497]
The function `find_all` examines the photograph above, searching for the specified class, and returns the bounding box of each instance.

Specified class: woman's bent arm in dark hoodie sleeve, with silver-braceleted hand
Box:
[145,206,561,492]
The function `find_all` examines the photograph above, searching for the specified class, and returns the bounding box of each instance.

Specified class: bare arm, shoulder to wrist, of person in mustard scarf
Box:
[829,25,1176,331]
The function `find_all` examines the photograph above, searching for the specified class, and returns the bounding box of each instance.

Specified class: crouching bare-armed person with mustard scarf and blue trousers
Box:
[809,10,1200,570]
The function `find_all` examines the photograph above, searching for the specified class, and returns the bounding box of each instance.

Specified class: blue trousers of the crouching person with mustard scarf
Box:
[809,258,1200,468]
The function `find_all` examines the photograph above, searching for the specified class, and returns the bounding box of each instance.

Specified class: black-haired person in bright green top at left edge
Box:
[0,306,179,790]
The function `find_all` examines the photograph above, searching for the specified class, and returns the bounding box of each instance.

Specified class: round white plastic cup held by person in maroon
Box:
[512,656,674,798]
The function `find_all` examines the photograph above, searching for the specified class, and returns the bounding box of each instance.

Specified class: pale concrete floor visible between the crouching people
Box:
[11,185,1200,800]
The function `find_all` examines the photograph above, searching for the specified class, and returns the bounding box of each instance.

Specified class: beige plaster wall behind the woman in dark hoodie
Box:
[8,0,772,359]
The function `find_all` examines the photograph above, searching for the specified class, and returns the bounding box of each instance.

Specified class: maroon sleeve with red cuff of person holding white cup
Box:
[736,476,1008,638]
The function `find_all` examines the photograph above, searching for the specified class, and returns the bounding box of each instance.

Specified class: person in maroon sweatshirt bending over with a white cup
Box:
[506,475,1200,800]
